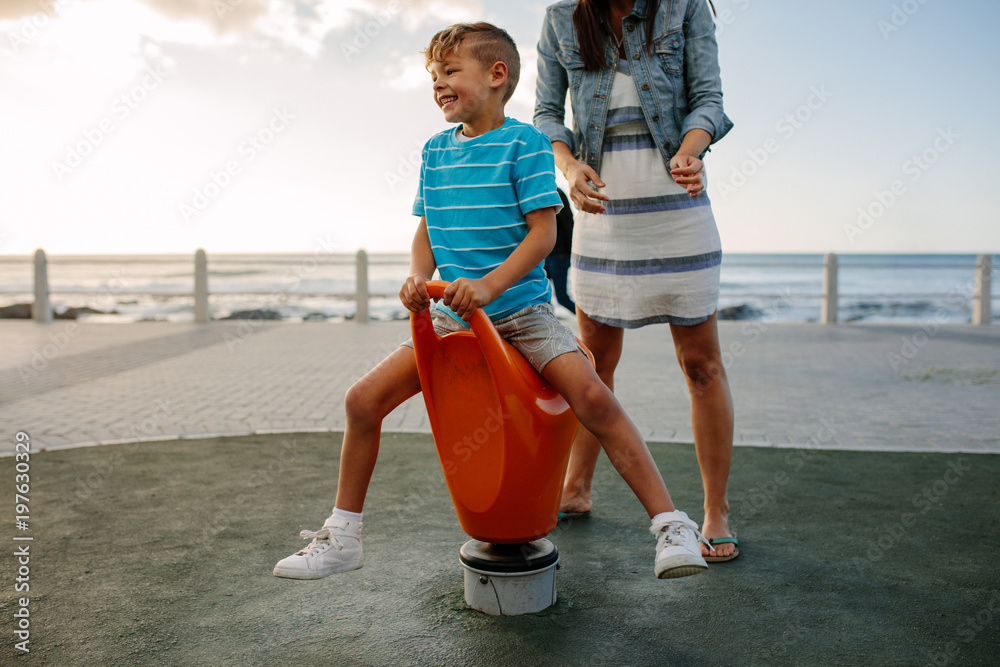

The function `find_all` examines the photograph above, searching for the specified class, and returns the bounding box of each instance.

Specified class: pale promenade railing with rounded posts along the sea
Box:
[0,249,995,325]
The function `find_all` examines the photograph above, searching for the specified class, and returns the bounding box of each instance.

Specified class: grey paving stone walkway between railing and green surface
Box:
[0,321,1000,454]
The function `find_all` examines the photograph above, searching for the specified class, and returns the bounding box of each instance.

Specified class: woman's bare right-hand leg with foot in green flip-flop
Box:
[670,315,736,556]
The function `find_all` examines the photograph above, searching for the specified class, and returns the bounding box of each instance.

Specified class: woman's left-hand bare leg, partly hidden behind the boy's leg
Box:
[559,306,624,512]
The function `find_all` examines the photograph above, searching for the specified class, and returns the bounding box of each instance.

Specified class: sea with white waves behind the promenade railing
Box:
[0,253,1000,324]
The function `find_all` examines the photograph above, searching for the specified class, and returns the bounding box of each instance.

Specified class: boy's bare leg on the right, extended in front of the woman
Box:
[542,352,674,518]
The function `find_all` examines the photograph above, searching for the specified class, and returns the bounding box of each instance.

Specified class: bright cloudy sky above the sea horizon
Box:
[0,0,1000,255]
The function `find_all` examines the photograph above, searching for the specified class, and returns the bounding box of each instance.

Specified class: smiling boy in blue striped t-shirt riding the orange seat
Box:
[274,23,707,579]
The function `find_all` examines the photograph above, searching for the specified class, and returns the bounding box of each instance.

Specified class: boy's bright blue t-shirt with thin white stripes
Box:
[413,118,562,320]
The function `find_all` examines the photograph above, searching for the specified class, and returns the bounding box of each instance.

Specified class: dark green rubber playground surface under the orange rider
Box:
[0,433,1000,666]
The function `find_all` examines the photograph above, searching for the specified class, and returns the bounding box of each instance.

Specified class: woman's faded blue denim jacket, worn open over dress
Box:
[534,0,733,173]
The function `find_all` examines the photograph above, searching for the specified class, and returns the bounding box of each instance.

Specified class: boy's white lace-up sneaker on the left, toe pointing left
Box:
[274,516,365,579]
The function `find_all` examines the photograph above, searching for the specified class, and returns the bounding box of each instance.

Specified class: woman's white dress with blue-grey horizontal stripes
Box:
[570,60,722,329]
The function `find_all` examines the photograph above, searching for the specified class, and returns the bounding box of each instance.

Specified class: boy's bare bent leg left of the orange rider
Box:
[336,346,420,512]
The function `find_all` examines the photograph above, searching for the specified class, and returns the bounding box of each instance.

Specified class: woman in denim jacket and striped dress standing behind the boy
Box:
[534,0,739,561]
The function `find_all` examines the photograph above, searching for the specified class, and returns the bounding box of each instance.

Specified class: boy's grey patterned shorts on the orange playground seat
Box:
[403,303,583,373]
